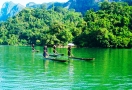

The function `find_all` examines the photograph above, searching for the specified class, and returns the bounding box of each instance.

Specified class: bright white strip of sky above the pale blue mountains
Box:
[0,0,68,8]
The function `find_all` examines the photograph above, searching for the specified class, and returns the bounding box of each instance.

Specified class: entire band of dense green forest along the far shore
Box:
[0,2,132,48]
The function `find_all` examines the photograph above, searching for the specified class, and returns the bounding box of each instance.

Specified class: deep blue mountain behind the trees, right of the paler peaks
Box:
[64,0,132,14]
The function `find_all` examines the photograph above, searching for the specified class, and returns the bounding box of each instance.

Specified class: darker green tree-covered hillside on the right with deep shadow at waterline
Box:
[74,2,132,48]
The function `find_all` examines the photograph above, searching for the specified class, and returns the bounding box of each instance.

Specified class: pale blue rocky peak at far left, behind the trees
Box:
[0,1,25,21]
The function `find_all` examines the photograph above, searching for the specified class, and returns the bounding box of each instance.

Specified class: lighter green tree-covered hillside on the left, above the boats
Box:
[0,7,83,45]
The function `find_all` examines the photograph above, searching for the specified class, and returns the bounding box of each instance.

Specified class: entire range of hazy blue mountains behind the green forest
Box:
[0,0,132,21]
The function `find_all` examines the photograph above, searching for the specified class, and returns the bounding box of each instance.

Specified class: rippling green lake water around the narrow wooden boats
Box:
[0,46,132,90]
